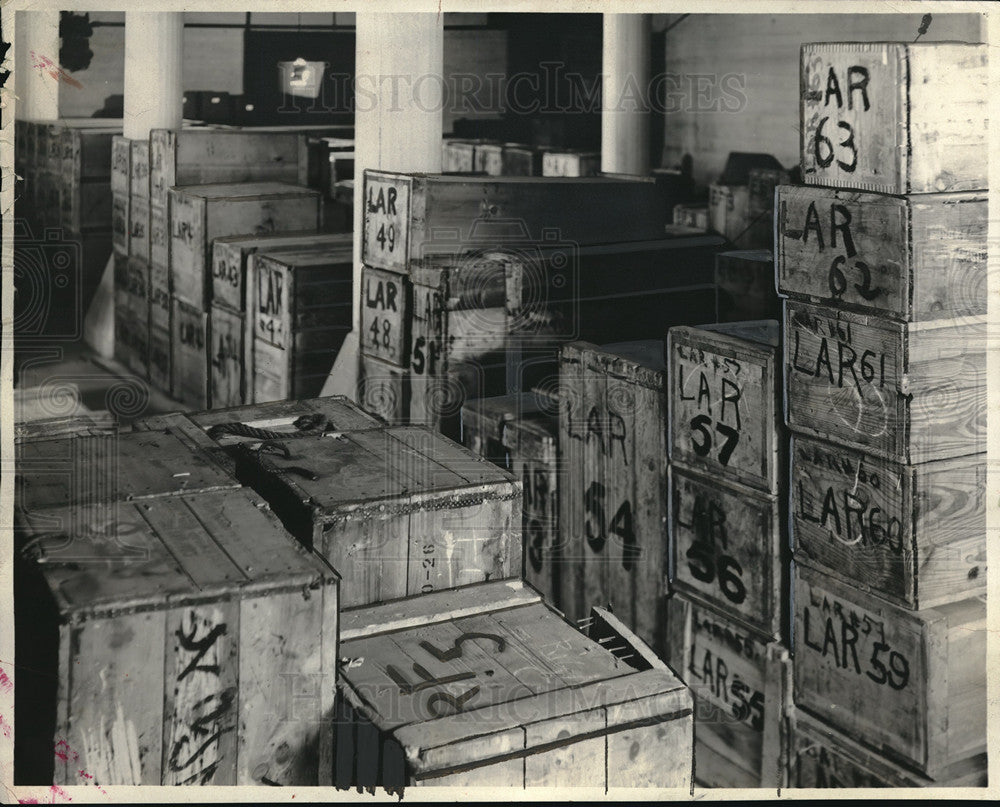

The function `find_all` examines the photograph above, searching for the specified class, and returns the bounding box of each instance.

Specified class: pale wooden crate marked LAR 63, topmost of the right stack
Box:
[800,42,987,194]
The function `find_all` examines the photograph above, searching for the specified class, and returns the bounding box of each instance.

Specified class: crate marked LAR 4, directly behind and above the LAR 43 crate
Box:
[169,182,320,308]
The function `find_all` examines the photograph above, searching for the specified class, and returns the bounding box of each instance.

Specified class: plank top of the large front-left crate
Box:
[17,490,337,621]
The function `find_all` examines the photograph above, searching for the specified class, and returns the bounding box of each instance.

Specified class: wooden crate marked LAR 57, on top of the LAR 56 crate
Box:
[667,320,787,494]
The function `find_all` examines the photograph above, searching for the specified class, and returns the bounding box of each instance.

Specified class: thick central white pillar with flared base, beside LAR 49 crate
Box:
[323,11,444,398]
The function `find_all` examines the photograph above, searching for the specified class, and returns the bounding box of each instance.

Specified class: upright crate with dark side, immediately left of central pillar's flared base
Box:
[247,246,354,403]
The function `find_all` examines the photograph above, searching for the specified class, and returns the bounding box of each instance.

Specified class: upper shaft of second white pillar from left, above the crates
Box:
[122,11,184,140]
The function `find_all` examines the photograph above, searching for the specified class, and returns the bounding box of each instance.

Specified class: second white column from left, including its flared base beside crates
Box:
[83,11,184,359]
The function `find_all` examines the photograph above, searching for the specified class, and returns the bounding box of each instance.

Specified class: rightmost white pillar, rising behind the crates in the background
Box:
[601,14,650,174]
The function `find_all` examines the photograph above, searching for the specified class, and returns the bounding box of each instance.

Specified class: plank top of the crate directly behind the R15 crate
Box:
[237,426,516,517]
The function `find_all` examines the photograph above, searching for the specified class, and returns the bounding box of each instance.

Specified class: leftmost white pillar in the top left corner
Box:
[14,11,62,121]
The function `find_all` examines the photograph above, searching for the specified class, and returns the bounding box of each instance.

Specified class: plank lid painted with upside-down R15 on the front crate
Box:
[338,580,691,774]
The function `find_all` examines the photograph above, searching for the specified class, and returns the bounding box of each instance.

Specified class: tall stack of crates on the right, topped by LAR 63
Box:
[777,43,987,786]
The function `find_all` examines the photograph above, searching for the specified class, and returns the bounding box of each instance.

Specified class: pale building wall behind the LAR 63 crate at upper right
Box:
[654,14,986,188]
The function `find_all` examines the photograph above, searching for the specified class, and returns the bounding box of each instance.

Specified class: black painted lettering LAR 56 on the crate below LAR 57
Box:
[674,490,747,605]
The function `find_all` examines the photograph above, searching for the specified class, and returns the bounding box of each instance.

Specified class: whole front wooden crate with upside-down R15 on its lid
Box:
[334,580,692,793]
